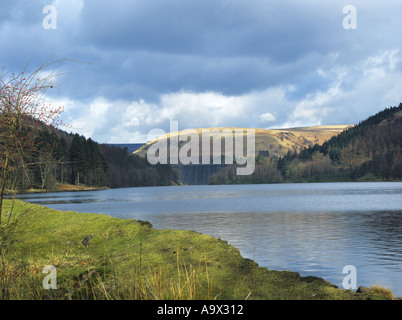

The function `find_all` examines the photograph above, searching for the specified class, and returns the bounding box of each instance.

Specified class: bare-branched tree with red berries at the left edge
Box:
[0,59,67,226]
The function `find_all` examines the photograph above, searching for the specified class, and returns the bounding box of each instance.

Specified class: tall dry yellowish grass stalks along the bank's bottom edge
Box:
[0,245,217,300]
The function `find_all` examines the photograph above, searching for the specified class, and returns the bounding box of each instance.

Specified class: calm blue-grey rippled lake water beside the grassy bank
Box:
[20,182,402,296]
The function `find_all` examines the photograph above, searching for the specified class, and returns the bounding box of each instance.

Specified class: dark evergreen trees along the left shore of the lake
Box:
[8,129,178,190]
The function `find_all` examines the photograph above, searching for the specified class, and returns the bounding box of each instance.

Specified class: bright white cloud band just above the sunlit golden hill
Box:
[48,88,286,142]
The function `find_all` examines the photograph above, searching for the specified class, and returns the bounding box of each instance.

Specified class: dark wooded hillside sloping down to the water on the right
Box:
[277,104,402,182]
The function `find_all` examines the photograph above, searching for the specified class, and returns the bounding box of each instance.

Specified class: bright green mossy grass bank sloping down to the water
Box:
[0,200,392,300]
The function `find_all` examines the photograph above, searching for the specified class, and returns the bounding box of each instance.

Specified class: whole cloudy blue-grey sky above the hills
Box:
[0,0,402,143]
